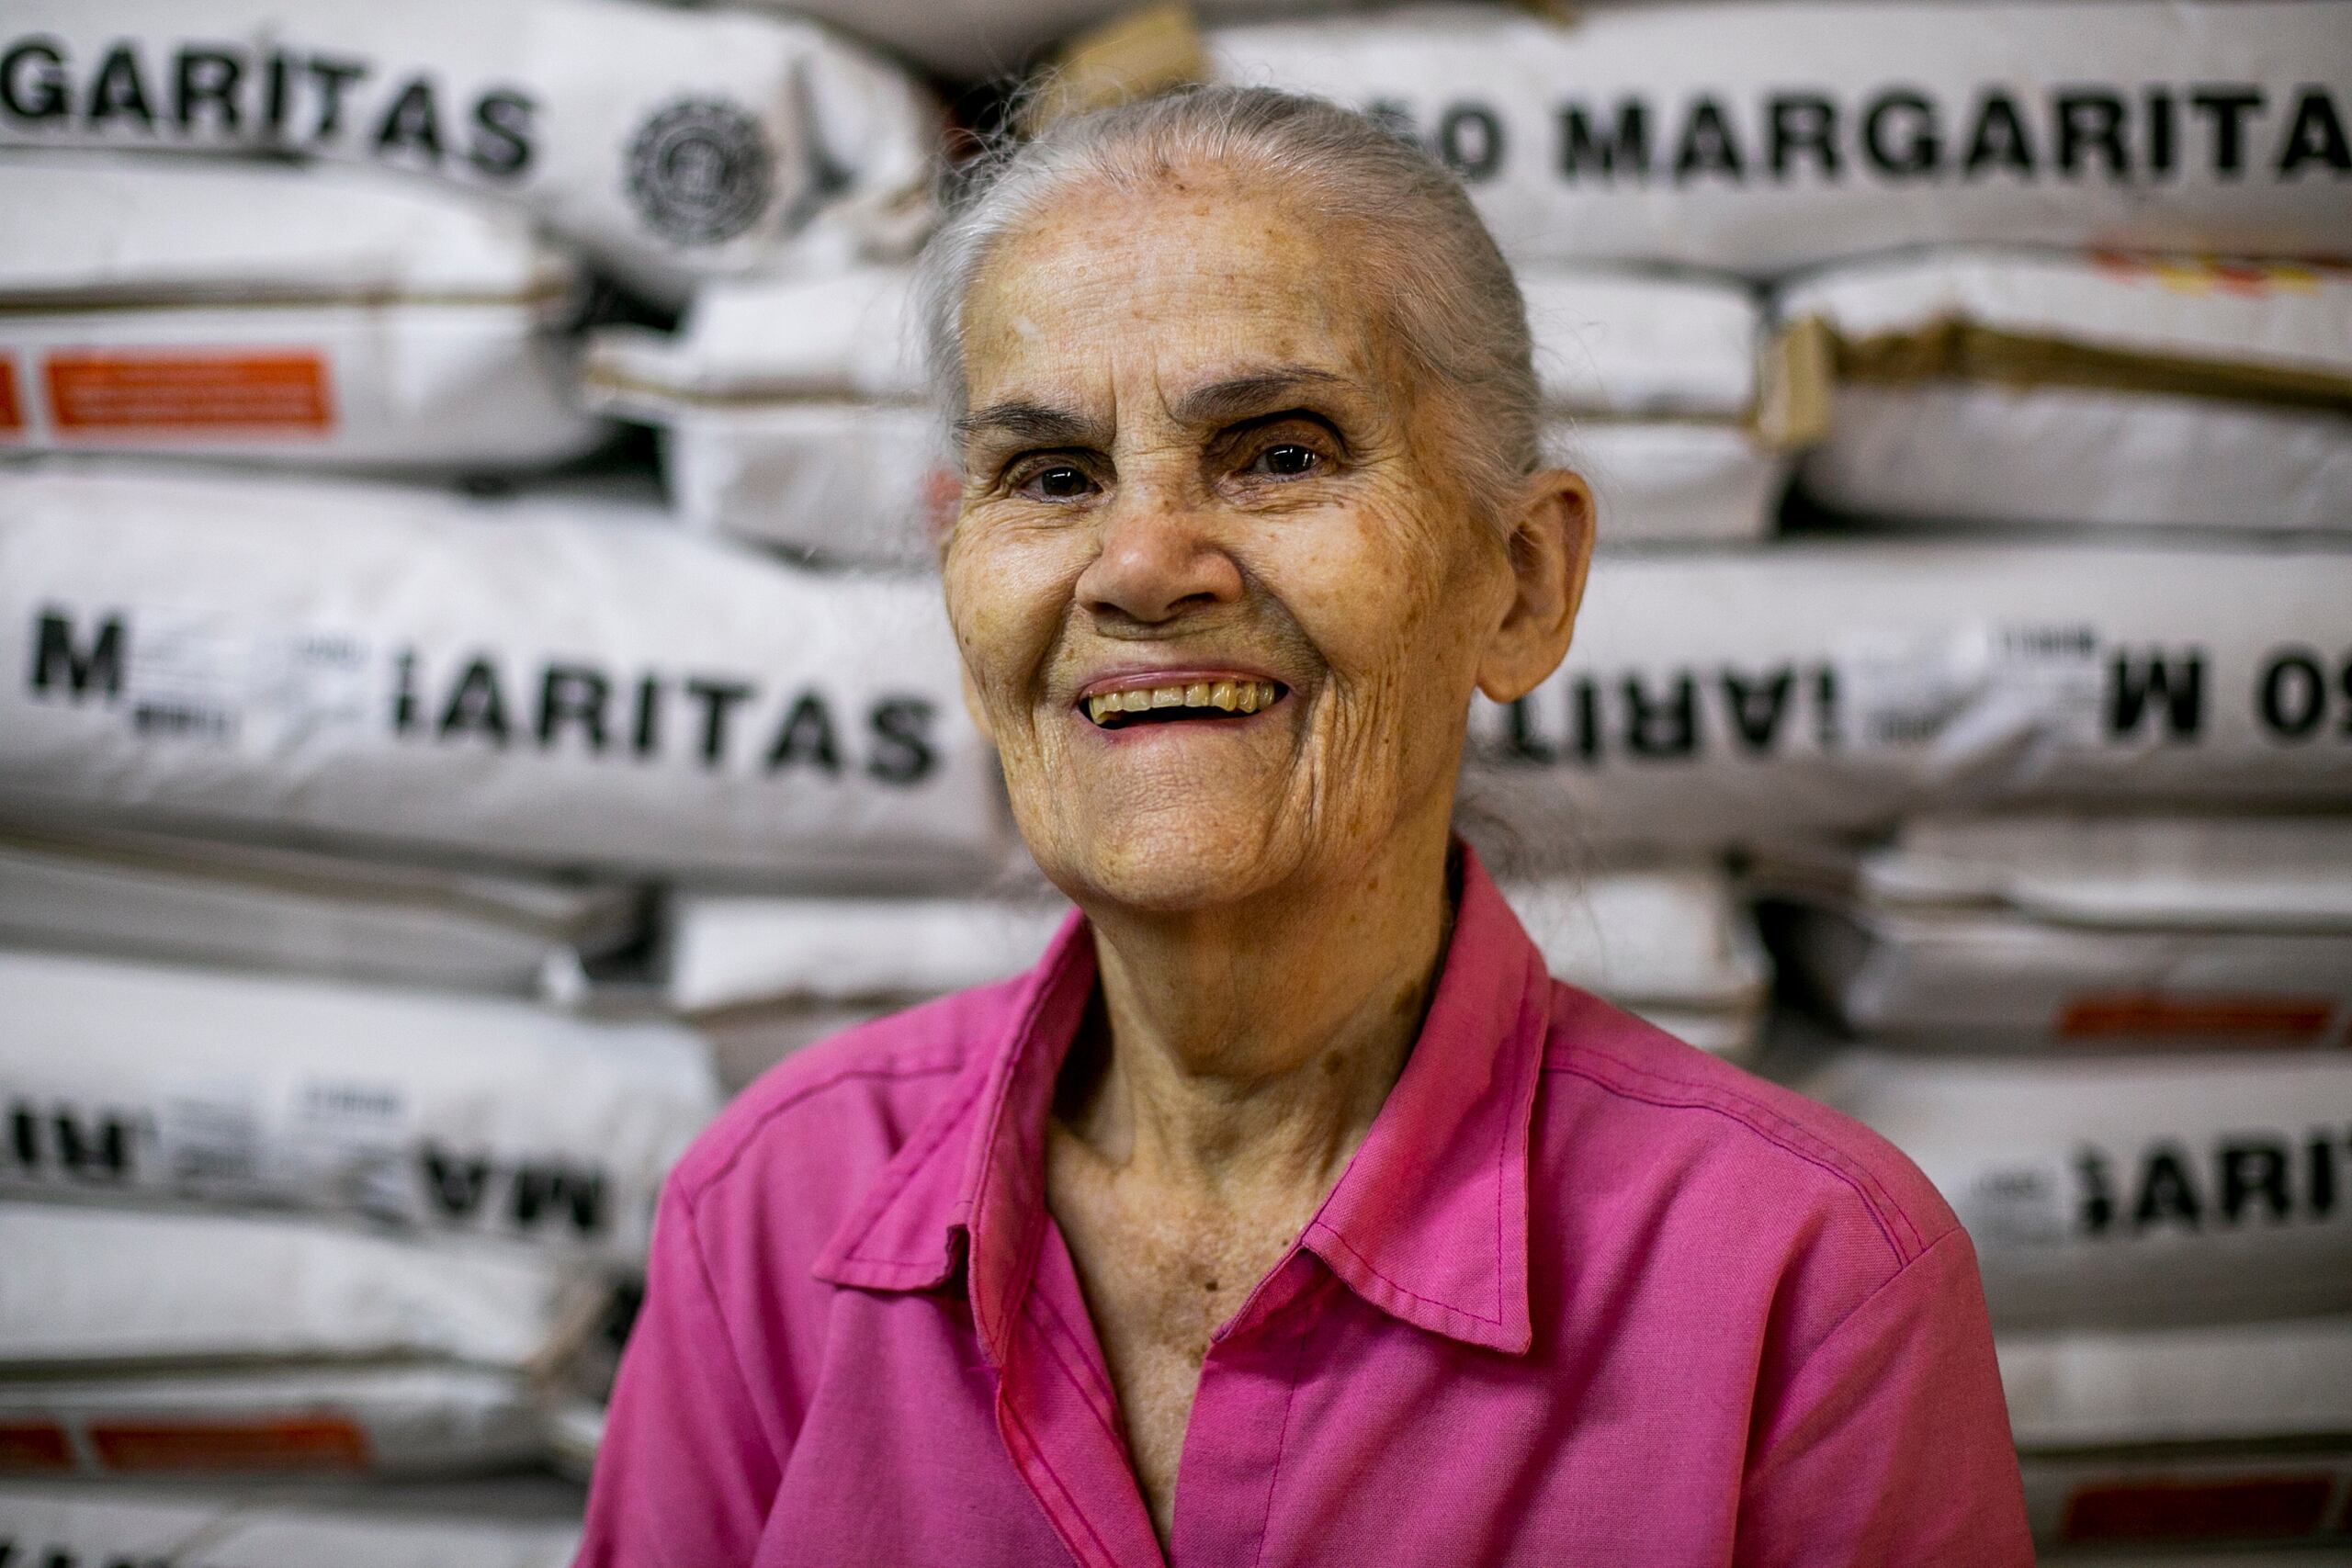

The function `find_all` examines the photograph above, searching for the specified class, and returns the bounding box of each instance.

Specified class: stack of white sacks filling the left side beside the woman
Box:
[0,0,964,1568]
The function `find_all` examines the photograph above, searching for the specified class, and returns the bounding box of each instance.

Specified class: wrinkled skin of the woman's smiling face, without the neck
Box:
[948,176,1557,909]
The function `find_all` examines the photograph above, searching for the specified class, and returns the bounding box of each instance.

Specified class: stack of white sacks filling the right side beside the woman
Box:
[1209,0,2352,1561]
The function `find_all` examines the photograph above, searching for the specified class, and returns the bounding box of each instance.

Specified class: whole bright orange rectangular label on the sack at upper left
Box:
[42,350,334,434]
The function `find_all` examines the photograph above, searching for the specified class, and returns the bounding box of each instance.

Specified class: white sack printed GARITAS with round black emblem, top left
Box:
[0,0,936,299]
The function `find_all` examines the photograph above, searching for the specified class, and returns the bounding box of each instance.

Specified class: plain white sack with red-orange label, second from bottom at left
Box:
[0,1203,606,1472]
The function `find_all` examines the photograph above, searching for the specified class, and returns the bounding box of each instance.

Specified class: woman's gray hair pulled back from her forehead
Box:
[917,87,1541,533]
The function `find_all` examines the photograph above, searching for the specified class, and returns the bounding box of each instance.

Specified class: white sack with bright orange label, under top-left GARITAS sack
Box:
[0,152,605,470]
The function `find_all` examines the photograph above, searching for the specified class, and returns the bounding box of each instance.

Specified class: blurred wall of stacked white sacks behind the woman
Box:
[0,0,2352,1568]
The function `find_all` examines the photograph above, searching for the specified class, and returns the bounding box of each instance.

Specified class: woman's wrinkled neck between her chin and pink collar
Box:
[1056,835,1453,1201]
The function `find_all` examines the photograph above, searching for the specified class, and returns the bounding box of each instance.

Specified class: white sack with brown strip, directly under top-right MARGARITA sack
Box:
[1778,252,2352,529]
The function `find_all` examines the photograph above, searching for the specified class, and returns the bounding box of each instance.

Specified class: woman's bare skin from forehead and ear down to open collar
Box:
[944,167,1592,1544]
